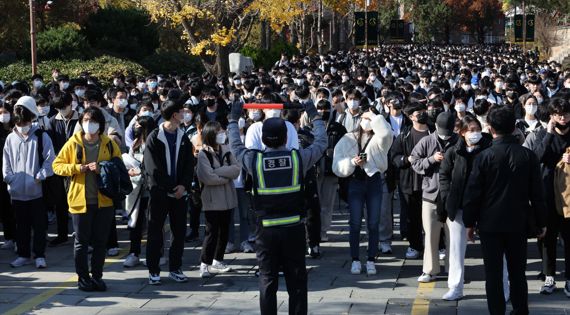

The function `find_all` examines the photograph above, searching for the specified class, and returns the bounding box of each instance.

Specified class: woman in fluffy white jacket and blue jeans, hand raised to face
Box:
[333,112,393,275]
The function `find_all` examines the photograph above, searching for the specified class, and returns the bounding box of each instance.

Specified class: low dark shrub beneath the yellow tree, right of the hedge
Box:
[141,51,205,74]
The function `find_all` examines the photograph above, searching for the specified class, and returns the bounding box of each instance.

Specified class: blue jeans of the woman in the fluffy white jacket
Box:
[348,173,382,259]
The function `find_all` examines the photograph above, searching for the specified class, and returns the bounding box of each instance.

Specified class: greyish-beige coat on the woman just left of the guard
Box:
[196,145,241,211]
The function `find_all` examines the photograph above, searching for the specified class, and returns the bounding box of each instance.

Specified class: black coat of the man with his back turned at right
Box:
[463,135,546,236]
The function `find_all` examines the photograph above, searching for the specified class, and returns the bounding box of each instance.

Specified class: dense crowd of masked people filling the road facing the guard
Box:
[0,45,570,314]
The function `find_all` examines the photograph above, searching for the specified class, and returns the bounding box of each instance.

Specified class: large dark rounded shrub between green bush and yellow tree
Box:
[82,7,160,60]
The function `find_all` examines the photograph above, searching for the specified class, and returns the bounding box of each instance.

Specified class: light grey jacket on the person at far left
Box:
[2,126,55,201]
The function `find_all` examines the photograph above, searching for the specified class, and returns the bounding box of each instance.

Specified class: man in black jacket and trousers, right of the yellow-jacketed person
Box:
[144,100,194,285]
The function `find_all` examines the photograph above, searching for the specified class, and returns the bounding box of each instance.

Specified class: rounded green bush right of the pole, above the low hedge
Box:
[37,26,91,60]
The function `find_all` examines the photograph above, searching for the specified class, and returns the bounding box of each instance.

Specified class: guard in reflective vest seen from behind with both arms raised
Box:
[228,102,327,315]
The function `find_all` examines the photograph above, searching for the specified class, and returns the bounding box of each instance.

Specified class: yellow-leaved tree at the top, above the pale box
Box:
[141,0,259,74]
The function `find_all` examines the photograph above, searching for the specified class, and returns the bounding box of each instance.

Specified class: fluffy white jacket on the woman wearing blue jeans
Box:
[332,115,393,177]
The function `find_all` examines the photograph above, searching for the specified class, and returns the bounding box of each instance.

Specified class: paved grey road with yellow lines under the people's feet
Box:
[0,204,570,315]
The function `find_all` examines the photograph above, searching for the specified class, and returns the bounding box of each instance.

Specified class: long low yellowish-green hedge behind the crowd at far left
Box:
[0,56,149,82]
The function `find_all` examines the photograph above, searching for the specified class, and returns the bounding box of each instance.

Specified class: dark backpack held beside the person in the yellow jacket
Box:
[97,141,133,205]
